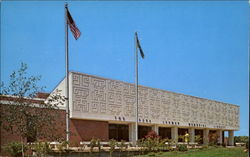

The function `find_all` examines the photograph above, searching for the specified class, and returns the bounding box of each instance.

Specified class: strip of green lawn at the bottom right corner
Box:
[136,148,248,157]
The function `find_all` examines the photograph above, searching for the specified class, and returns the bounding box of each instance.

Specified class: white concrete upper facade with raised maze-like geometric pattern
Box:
[54,72,239,130]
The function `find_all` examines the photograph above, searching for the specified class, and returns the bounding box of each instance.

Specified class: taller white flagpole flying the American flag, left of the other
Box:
[65,3,70,142]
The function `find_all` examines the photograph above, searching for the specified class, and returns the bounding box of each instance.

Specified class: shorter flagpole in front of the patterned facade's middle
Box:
[135,31,138,142]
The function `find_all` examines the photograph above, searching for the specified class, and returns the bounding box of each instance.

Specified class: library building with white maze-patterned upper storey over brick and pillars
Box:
[49,72,239,145]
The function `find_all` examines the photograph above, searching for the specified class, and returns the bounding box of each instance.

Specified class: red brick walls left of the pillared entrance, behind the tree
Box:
[0,95,109,155]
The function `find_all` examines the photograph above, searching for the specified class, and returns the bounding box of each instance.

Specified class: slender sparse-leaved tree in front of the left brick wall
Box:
[0,63,65,156]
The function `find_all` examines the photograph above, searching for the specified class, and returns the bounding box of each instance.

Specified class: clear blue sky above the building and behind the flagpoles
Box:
[1,1,249,135]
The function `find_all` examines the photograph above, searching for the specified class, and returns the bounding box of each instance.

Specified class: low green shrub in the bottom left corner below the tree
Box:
[4,142,27,157]
